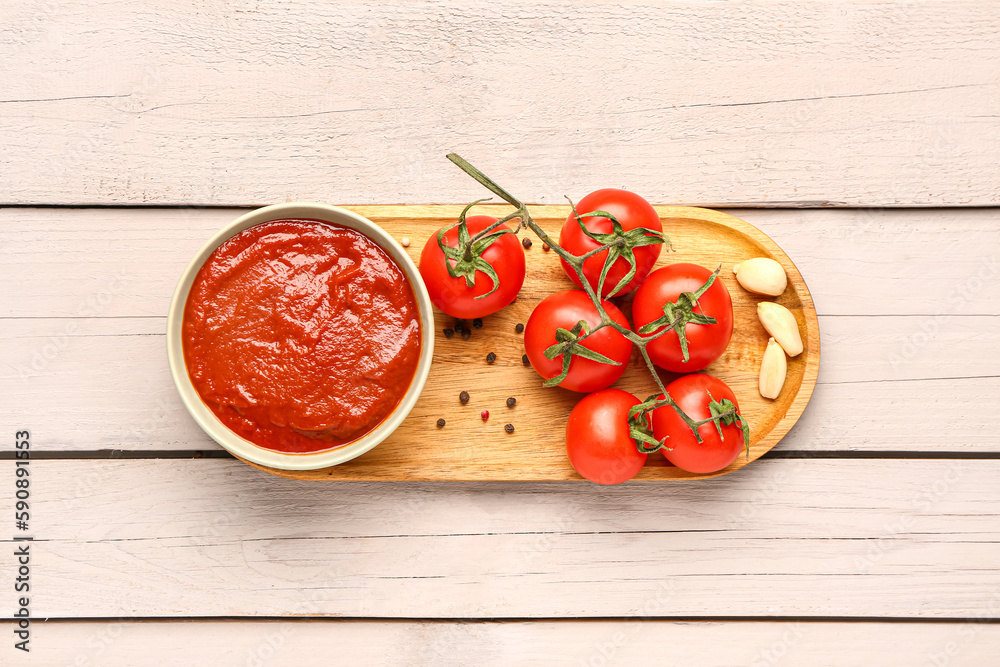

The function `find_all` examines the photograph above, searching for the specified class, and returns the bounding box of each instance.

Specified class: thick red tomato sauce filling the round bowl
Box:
[182,220,421,453]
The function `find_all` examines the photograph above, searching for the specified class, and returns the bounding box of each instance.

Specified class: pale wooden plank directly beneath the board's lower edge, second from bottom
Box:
[11,460,1000,619]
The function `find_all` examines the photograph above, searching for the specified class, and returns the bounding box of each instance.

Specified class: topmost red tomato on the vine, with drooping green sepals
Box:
[559,188,663,297]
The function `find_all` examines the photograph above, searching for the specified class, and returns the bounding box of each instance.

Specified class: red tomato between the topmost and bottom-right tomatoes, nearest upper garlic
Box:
[632,264,733,373]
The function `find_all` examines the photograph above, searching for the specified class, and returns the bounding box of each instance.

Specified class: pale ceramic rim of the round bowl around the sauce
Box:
[167,202,434,470]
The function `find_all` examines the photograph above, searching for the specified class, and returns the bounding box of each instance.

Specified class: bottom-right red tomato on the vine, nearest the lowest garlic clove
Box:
[653,373,744,473]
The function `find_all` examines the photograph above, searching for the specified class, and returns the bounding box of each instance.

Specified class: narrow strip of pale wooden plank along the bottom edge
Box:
[25,619,1000,667]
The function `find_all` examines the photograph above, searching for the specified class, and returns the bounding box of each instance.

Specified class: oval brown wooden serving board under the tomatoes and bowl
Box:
[244,206,819,481]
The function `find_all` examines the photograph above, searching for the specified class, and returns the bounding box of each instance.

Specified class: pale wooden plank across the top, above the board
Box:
[0,0,1000,206]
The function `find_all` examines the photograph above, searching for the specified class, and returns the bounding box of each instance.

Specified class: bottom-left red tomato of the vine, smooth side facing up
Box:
[566,389,647,484]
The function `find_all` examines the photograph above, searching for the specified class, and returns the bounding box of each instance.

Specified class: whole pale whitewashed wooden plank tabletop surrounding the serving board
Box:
[0,0,1000,666]
